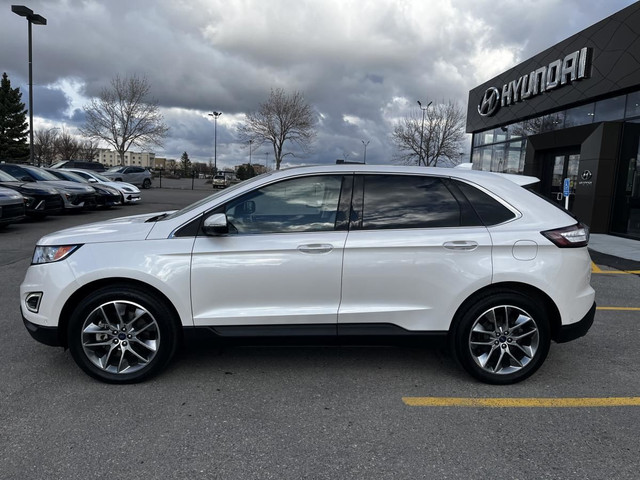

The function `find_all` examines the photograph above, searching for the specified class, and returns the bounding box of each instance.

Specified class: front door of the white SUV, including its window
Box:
[191,175,347,328]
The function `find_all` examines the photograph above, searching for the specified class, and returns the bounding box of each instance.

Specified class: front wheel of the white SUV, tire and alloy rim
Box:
[67,285,179,383]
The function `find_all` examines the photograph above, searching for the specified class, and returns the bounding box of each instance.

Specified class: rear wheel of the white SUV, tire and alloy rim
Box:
[451,290,551,385]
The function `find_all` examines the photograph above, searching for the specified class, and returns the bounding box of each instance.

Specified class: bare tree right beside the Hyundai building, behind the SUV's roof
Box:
[392,100,465,167]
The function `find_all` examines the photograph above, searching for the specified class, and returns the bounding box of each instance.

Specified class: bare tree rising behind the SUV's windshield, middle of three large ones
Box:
[238,88,317,170]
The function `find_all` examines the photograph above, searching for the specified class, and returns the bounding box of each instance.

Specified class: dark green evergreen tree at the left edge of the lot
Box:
[0,72,29,162]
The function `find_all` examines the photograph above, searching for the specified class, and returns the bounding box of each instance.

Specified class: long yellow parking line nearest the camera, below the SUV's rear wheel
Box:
[402,397,640,408]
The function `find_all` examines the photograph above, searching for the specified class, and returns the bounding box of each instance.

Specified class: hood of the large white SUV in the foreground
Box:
[38,212,168,245]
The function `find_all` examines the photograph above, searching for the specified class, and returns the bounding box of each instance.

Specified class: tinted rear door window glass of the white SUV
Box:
[362,175,462,230]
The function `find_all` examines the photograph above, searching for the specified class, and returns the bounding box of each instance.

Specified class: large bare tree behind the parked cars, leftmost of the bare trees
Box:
[80,75,169,165]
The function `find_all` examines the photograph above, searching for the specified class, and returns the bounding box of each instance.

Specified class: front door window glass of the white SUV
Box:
[225,175,342,234]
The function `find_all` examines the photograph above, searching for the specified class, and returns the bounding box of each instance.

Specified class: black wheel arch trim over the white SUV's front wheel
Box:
[58,277,183,348]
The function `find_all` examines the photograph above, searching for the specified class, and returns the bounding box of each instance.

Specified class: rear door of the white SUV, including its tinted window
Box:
[338,174,492,334]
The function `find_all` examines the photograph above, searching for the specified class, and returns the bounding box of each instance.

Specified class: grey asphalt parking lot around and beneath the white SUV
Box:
[0,188,640,479]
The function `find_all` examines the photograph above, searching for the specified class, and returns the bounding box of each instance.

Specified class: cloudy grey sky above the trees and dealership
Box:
[0,0,634,170]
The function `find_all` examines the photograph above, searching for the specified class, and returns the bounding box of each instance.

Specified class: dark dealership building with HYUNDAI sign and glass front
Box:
[467,2,640,239]
